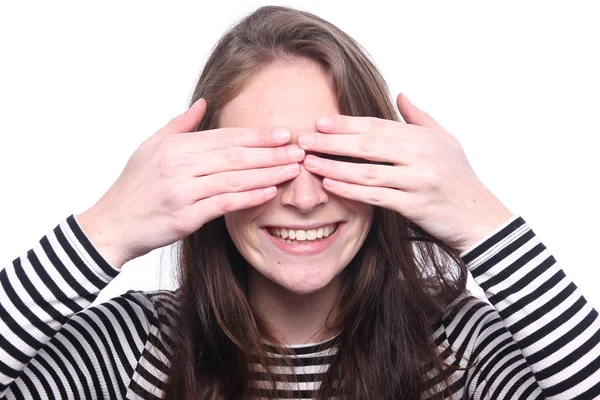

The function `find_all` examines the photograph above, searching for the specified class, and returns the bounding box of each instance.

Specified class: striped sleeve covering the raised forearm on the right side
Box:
[461,216,600,400]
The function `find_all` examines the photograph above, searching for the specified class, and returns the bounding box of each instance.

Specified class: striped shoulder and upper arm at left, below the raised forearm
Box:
[49,290,184,398]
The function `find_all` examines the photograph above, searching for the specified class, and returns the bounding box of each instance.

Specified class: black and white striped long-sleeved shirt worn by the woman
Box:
[0,215,600,399]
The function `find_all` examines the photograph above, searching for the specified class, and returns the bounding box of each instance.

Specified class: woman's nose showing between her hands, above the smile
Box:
[278,164,329,214]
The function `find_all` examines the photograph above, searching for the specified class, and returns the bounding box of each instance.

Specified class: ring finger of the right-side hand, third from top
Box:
[303,154,422,191]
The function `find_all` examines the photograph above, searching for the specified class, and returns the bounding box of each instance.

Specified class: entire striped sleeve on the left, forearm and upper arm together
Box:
[0,215,148,398]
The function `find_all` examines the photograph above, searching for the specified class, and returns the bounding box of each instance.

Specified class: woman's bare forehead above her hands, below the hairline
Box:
[219,59,339,141]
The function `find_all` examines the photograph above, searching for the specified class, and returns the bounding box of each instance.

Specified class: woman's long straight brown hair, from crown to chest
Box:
[164,6,467,400]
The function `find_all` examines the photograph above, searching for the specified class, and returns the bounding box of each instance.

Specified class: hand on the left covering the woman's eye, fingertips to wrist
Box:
[77,99,304,268]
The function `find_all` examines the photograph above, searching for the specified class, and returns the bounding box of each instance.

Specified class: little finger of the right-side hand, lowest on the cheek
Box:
[323,178,411,213]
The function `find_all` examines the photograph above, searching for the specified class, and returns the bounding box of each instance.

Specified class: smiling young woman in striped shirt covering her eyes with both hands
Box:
[0,7,600,399]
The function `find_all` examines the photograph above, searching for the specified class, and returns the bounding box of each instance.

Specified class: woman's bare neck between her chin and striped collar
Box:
[248,267,343,345]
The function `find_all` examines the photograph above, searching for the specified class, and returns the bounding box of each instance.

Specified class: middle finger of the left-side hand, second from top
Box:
[184,144,305,176]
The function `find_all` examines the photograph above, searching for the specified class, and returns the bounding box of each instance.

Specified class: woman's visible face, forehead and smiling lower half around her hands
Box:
[219,60,373,294]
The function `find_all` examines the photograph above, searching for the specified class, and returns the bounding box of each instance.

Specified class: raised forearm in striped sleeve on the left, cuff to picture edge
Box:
[0,216,119,396]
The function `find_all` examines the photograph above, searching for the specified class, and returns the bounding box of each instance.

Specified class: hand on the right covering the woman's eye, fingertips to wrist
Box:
[298,94,513,252]
